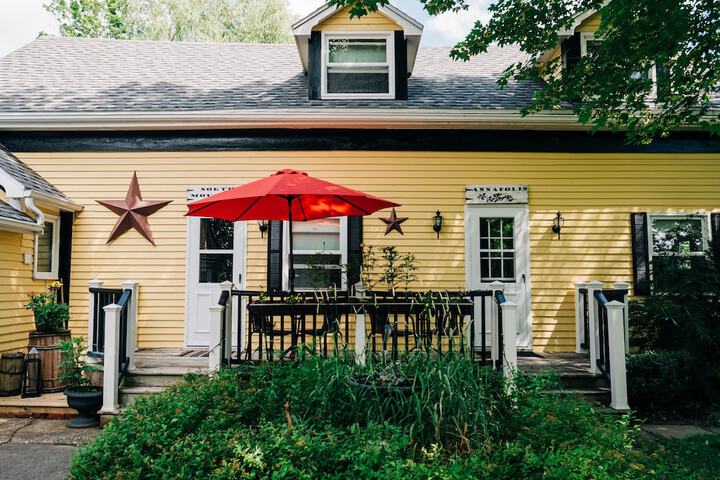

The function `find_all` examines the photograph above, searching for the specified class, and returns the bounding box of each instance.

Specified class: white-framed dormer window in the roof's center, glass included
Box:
[321,32,395,99]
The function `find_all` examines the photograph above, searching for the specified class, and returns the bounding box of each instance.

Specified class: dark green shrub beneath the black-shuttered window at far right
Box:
[628,242,720,415]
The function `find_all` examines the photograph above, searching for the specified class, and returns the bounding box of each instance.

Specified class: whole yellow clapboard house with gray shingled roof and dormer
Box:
[0,2,720,360]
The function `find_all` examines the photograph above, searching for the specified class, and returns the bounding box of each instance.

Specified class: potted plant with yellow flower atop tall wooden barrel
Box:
[25,282,70,393]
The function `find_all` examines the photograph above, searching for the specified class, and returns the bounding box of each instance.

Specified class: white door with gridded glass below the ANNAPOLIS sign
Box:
[465,205,532,348]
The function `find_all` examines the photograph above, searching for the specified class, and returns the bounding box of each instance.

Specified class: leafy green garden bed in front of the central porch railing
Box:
[70,358,720,480]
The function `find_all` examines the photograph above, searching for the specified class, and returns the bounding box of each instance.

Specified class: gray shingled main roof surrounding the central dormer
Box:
[0,37,538,113]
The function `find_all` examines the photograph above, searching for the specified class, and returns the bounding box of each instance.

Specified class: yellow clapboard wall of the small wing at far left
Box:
[0,230,46,353]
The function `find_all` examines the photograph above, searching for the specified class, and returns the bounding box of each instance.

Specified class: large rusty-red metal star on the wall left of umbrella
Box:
[95,172,172,246]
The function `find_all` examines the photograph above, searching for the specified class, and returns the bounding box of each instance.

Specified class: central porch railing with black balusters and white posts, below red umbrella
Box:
[208,282,518,373]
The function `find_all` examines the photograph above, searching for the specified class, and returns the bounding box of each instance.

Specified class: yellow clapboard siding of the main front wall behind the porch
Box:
[15,151,720,350]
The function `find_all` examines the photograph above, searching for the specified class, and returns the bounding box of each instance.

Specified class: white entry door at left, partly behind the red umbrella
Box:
[185,217,247,347]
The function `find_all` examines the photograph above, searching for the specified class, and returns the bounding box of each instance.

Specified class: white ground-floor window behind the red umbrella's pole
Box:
[285,217,347,291]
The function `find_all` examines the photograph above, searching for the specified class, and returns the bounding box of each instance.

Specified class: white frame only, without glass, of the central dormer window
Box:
[320,30,395,100]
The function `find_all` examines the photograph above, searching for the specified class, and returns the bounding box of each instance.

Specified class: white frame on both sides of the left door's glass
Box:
[184,217,247,348]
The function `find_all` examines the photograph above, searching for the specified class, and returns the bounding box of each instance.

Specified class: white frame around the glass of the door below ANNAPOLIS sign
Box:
[465,204,532,349]
